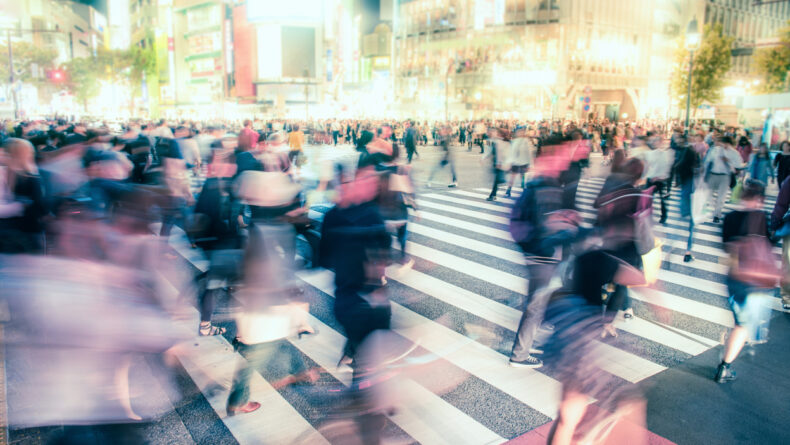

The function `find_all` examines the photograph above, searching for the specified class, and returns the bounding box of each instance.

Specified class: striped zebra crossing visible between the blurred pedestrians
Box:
[164,178,780,444]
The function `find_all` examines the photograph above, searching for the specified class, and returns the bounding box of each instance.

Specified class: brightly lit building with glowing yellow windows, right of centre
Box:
[393,0,684,119]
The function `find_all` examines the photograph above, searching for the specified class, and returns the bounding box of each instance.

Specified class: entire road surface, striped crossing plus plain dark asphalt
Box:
[7,147,790,444]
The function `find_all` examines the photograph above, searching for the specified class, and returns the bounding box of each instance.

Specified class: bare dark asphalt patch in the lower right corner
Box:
[643,312,790,444]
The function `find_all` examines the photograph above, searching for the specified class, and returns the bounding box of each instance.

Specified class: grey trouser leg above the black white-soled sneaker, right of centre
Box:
[510,264,555,362]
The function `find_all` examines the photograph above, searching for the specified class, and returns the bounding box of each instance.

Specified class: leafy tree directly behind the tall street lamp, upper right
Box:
[672,24,734,110]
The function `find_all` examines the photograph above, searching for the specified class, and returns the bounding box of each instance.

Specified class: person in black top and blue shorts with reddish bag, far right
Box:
[715,179,780,383]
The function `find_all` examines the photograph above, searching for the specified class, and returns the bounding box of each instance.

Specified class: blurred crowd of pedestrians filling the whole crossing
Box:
[0,115,790,443]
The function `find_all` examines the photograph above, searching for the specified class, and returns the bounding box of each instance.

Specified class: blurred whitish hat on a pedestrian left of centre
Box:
[237,170,302,207]
